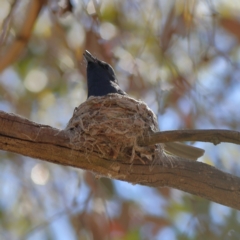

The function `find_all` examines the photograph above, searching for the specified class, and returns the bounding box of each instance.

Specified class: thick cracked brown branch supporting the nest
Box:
[0,111,240,210]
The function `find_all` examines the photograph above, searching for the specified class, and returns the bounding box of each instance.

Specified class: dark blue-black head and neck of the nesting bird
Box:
[83,50,126,98]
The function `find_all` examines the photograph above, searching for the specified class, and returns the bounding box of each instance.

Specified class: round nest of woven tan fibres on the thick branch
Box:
[66,94,162,164]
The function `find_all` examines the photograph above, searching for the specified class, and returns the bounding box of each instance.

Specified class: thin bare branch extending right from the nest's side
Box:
[140,129,240,146]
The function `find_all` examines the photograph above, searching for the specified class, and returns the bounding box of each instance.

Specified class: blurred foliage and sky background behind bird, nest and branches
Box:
[0,0,240,240]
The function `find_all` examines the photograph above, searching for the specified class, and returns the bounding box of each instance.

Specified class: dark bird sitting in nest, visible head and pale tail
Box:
[83,50,205,160]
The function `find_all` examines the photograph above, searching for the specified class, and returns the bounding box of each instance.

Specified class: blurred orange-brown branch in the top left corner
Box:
[0,0,45,72]
